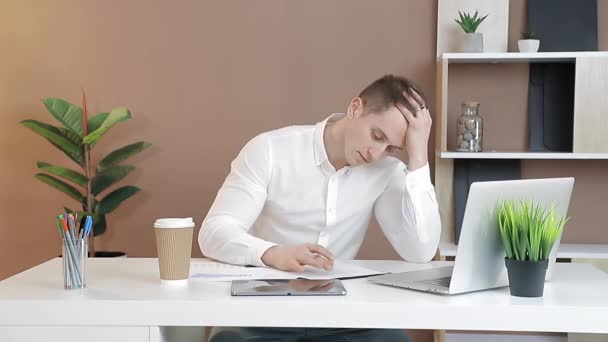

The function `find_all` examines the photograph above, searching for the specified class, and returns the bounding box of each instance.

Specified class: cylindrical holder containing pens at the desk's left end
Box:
[61,237,89,289]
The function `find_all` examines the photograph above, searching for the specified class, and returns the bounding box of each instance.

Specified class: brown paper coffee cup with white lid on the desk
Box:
[154,217,194,285]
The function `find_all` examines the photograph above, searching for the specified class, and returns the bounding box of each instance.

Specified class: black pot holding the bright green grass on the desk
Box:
[505,258,549,297]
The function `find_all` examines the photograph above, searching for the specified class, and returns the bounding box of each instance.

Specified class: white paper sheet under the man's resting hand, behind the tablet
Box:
[190,260,380,281]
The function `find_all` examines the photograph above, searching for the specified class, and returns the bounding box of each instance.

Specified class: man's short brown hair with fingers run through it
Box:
[359,75,426,115]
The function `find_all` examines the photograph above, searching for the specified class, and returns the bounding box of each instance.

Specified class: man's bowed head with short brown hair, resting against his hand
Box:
[344,75,425,166]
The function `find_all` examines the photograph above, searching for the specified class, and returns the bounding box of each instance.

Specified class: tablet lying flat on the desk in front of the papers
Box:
[230,279,346,296]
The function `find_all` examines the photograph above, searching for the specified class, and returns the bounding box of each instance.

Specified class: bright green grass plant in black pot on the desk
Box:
[497,200,568,297]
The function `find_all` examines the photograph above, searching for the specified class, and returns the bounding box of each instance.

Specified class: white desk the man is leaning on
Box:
[0,258,608,342]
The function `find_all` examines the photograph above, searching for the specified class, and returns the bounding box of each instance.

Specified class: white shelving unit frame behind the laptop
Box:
[434,51,608,259]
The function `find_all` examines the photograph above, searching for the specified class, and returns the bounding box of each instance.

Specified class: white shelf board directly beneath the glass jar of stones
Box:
[440,152,608,160]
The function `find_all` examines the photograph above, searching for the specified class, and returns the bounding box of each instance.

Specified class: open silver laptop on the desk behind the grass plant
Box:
[368,177,574,295]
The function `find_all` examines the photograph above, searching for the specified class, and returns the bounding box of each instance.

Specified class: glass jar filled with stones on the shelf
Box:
[456,101,483,152]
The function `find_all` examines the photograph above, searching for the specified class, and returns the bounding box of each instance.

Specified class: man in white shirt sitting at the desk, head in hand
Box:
[199,75,441,342]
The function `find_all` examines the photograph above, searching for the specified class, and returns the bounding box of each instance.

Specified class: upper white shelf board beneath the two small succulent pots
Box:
[439,51,608,63]
